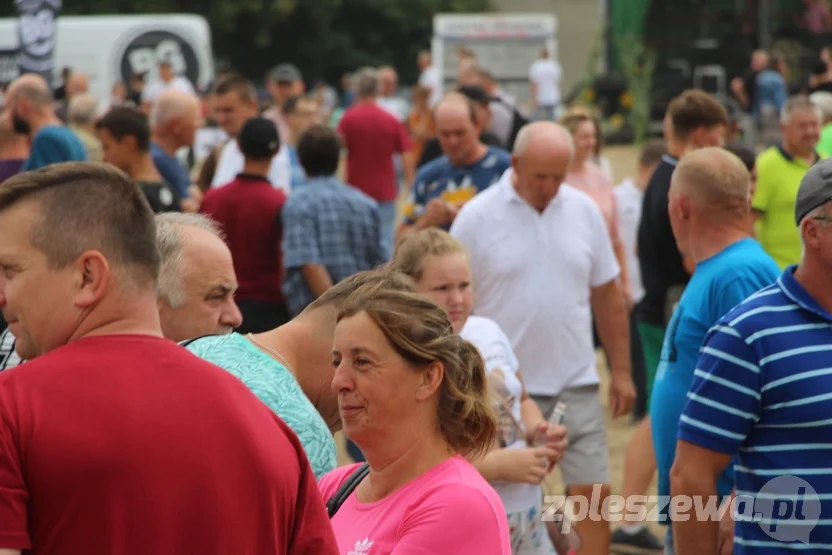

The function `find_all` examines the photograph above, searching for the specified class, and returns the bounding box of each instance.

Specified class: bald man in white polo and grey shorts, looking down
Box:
[451,122,635,555]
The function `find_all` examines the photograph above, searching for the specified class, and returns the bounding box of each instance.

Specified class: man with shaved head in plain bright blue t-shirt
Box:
[651,148,780,552]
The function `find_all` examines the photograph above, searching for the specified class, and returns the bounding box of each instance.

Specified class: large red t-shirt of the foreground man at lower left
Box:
[0,335,338,555]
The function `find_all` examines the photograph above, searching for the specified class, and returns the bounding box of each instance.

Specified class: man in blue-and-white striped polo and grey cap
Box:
[671,160,832,555]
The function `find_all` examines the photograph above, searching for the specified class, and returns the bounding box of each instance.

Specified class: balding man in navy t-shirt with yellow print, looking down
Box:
[399,93,511,239]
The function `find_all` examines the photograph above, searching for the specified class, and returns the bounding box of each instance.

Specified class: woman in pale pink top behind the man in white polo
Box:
[560,109,632,306]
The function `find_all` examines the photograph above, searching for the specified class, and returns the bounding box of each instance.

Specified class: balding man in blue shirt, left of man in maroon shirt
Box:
[150,89,202,204]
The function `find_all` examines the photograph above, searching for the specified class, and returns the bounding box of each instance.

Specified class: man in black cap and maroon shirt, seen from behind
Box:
[201,117,289,333]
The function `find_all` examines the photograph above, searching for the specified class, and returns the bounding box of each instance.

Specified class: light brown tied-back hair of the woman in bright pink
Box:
[338,276,497,458]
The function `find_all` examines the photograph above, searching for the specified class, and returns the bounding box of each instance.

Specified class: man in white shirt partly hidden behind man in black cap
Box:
[211,75,292,194]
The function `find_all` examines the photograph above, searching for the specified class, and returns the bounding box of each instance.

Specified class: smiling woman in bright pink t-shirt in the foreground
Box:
[318,274,511,555]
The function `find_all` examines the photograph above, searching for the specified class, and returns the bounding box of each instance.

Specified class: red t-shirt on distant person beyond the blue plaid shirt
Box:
[338,103,412,202]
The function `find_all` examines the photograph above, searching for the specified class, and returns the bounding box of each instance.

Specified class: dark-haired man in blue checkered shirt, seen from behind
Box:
[283,125,391,317]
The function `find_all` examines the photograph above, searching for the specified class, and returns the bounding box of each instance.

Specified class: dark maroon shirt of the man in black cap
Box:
[201,174,286,303]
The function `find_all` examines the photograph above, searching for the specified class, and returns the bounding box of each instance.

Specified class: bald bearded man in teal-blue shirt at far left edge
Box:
[6,73,87,171]
